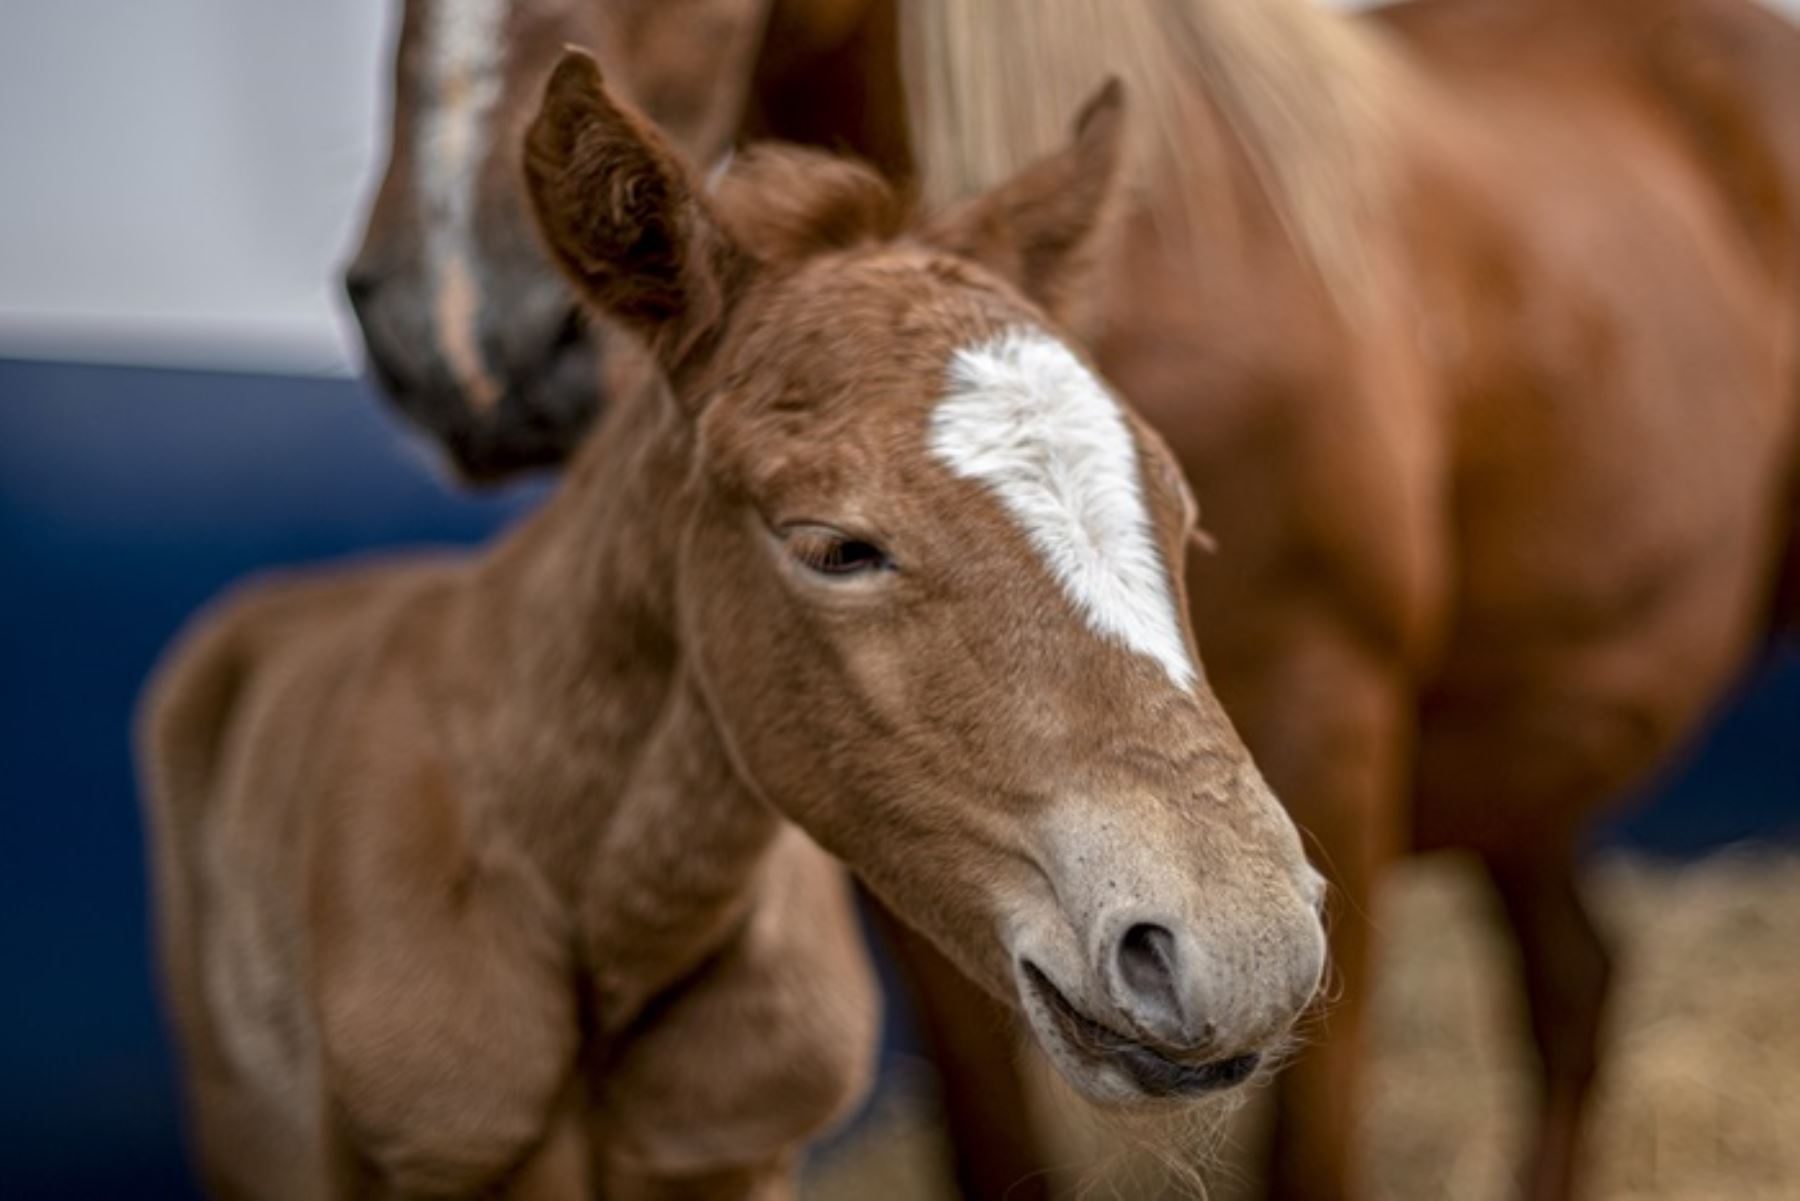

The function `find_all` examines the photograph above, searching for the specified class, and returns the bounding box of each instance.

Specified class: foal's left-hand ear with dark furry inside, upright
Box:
[526,49,751,393]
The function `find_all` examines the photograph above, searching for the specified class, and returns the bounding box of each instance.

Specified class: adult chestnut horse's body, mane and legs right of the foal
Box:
[347,0,1800,1197]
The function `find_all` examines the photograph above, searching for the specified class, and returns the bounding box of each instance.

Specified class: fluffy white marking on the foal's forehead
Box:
[931,328,1199,691]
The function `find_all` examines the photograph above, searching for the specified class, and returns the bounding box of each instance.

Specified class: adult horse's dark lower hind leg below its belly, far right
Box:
[1485,846,1611,1201]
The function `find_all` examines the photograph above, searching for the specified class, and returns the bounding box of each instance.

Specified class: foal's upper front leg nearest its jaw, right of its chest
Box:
[592,830,880,1201]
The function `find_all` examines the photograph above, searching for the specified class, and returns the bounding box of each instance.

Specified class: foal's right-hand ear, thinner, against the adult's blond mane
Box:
[923,76,1125,319]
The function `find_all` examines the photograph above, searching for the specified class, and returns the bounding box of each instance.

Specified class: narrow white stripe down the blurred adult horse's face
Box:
[414,0,508,407]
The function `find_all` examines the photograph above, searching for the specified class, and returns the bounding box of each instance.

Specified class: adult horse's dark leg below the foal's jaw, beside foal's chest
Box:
[869,898,1051,1201]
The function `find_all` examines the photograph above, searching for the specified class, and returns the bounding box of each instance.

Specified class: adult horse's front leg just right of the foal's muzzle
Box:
[1220,618,1411,1201]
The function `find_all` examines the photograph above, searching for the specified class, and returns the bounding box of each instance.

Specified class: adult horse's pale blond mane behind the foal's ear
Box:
[900,0,1408,309]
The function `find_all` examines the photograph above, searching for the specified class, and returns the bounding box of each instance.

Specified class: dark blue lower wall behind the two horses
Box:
[0,360,1800,1199]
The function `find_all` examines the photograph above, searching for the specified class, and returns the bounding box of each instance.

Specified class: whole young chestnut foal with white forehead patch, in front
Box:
[146,67,1325,1199]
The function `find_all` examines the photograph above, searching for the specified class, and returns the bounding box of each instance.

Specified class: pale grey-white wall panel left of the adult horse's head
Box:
[0,0,391,371]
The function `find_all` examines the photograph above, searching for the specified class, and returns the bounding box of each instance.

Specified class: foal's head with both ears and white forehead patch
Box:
[526,54,1323,1102]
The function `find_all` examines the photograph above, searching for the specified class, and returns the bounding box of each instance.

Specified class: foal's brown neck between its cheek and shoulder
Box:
[470,369,779,1028]
